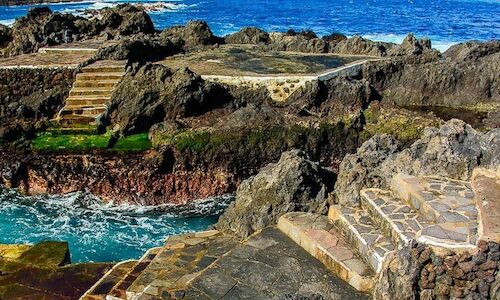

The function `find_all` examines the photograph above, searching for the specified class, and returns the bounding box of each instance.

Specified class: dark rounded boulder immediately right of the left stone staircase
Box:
[110,64,228,133]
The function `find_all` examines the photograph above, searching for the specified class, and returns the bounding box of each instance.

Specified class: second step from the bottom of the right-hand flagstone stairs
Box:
[328,205,396,273]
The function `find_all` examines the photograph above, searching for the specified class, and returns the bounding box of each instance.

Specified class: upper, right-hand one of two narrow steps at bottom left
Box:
[106,247,163,299]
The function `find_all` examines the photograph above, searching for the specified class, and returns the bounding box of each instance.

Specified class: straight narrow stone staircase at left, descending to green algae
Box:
[57,61,125,124]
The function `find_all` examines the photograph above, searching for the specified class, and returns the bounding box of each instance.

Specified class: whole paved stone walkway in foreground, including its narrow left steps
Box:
[82,227,367,300]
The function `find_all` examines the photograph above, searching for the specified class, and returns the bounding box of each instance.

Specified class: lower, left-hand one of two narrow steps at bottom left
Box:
[80,260,138,300]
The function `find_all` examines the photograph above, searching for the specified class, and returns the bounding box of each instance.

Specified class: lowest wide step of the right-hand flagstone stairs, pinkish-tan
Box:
[278,212,375,292]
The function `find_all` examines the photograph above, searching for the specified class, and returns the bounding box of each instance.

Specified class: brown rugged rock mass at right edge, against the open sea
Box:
[360,38,500,111]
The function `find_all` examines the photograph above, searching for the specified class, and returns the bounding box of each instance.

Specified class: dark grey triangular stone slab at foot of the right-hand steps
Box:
[184,227,368,300]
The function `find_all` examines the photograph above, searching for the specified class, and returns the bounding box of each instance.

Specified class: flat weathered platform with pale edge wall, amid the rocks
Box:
[158,45,380,101]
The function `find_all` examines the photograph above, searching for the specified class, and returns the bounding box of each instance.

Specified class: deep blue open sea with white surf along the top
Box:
[0,0,500,50]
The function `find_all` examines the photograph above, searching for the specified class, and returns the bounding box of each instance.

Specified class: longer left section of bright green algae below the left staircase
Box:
[31,132,111,152]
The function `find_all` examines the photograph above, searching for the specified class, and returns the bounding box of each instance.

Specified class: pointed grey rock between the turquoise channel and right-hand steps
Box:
[216,150,334,237]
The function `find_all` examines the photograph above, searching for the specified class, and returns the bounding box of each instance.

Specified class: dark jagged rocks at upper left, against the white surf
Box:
[4,5,154,56]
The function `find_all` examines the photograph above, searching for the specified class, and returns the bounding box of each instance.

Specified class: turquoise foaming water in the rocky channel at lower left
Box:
[0,190,231,262]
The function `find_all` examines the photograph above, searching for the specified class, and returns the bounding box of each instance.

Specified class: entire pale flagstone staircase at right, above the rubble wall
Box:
[278,174,478,292]
